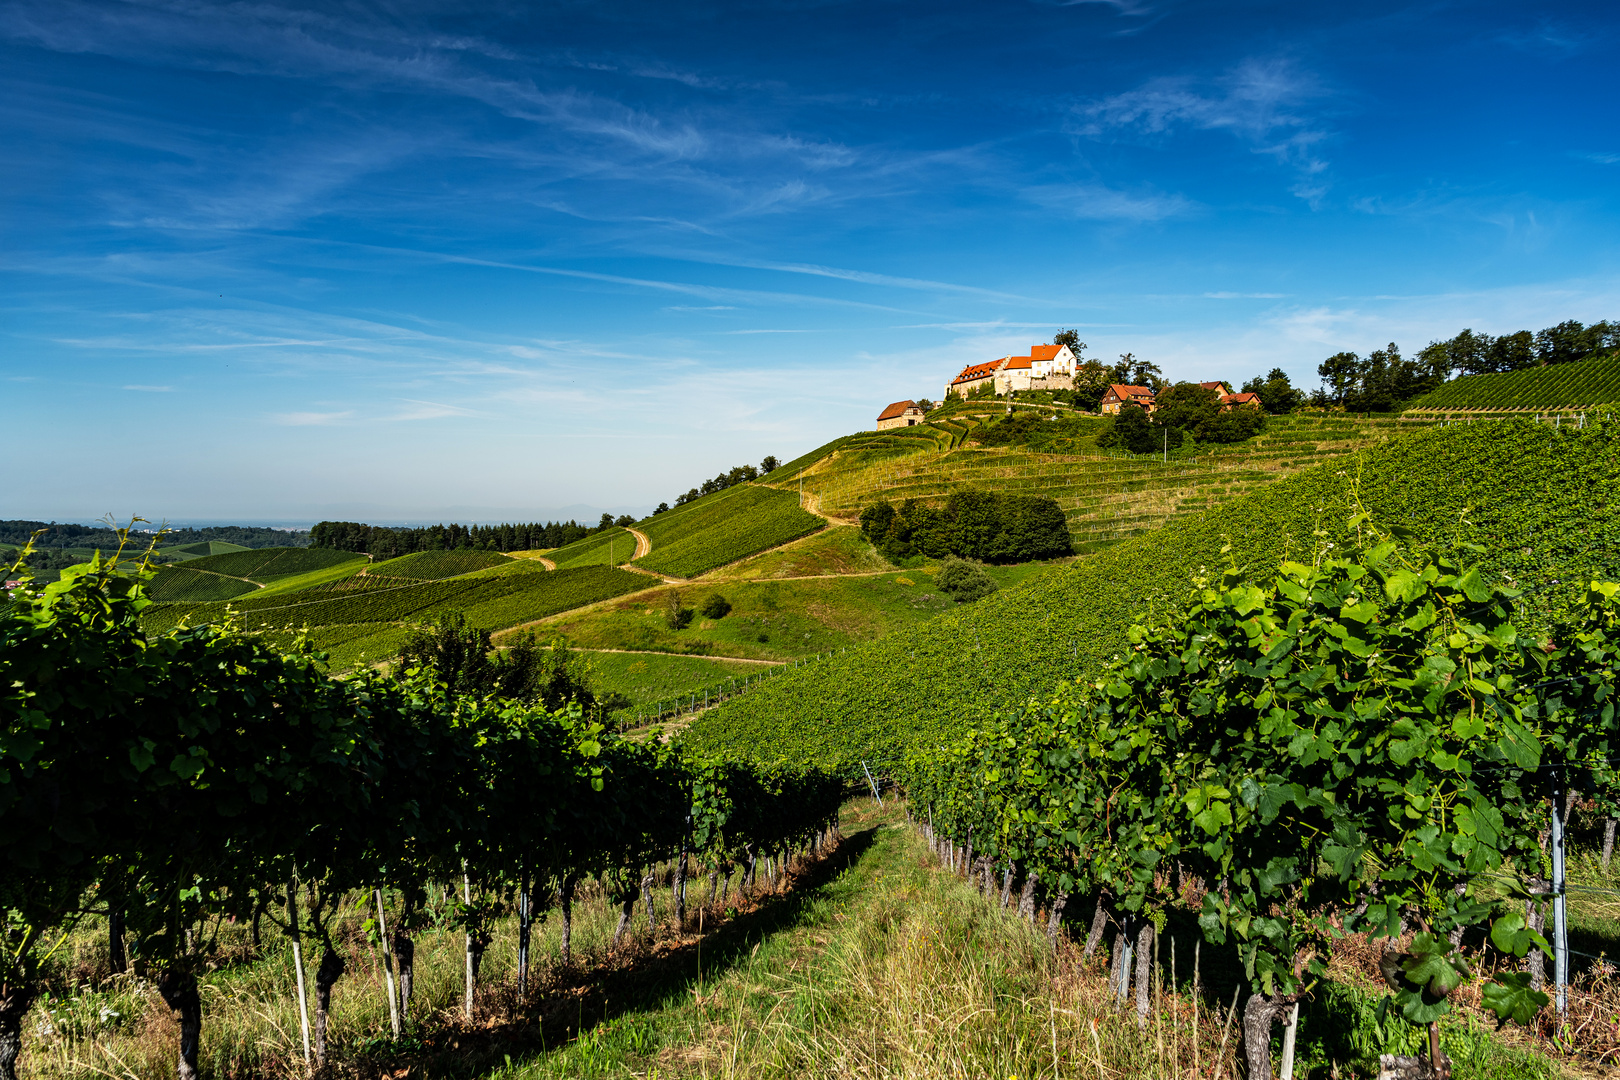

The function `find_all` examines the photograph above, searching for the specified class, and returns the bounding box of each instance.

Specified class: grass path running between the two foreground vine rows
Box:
[489,800,1230,1080]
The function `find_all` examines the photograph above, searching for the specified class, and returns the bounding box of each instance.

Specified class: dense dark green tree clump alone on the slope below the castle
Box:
[860,491,1074,563]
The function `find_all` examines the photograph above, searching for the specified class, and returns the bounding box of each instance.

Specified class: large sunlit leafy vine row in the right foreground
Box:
[907,513,1620,1080]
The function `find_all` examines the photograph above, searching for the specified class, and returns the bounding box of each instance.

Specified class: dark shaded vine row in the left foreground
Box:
[0,567,844,1080]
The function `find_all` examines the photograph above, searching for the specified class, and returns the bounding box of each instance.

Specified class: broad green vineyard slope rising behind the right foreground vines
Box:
[684,419,1620,766]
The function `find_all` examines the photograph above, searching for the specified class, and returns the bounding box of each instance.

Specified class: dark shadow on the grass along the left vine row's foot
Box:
[356,824,881,1078]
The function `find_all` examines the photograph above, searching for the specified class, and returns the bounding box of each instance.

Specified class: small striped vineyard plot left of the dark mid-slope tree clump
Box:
[635,484,826,578]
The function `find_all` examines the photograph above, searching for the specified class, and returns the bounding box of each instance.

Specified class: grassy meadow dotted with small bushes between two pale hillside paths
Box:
[511,563,1048,661]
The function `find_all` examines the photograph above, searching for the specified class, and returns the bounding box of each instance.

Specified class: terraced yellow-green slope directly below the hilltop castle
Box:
[771,416,1432,551]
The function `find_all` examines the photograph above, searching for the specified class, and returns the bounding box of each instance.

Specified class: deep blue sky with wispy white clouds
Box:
[0,0,1620,521]
